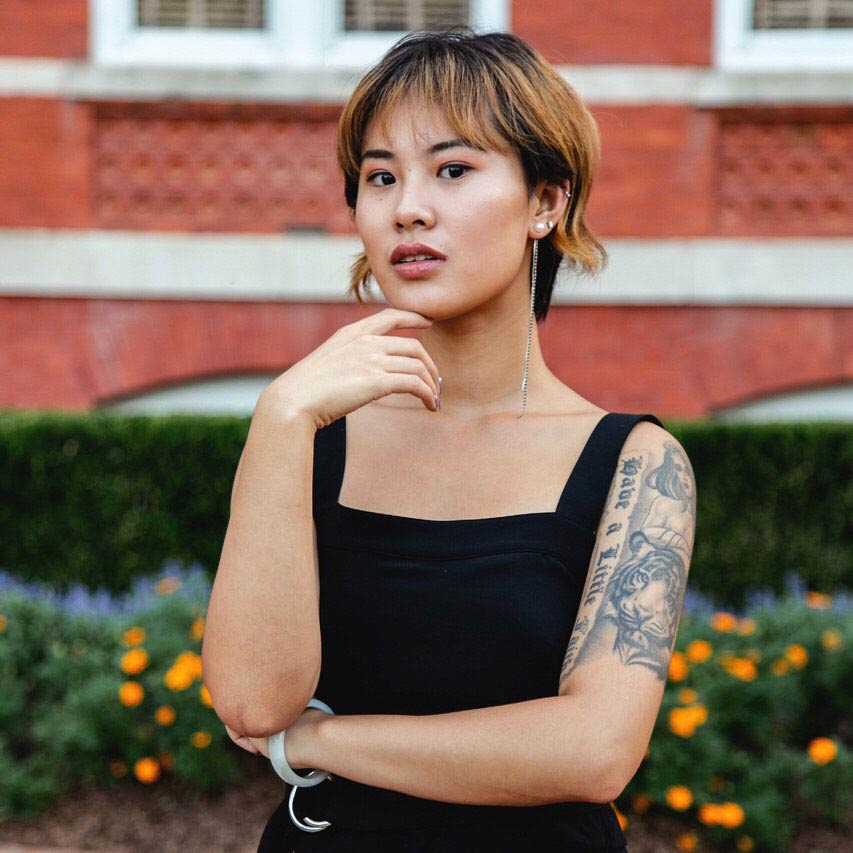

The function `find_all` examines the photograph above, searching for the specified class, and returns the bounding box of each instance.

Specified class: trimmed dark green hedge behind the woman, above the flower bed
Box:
[0,412,853,607]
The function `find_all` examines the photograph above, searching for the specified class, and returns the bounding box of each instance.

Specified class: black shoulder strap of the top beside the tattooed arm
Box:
[557,412,663,534]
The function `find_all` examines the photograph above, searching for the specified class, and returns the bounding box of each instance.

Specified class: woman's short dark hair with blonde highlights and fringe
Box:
[336,27,607,320]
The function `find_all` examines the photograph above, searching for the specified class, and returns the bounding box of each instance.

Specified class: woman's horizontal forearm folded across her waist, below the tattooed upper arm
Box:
[310,696,613,806]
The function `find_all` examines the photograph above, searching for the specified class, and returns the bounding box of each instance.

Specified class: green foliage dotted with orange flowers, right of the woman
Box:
[617,596,853,853]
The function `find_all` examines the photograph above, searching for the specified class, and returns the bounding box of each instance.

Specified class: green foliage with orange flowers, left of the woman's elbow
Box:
[0,590,239,820]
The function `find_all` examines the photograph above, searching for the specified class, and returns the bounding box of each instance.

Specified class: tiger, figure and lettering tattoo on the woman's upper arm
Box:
[560,441,696,686]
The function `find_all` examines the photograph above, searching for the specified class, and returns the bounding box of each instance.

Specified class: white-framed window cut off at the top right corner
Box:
[714,0,853,72]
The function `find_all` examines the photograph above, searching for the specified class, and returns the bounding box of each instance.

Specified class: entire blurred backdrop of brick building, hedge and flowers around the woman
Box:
[0,0,853,853]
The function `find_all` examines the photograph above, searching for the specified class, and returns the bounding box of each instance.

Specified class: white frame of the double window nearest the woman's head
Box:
[89,0,510,69]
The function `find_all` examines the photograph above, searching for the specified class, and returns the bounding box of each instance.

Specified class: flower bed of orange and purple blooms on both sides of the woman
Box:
[0,564,853,851]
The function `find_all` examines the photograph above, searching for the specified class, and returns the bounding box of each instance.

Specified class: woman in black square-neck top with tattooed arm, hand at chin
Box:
[203,28,695,853]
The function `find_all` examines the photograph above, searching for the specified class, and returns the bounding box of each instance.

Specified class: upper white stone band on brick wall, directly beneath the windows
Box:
[0,57,853,107]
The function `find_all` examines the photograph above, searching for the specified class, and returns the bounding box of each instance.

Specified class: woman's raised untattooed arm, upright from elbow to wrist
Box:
[202,391,320,736]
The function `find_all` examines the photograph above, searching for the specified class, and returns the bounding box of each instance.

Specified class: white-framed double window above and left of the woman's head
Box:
[89,0,511,69]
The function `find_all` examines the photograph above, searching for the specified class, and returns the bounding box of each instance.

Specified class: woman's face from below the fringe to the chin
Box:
[355,101,536,320]
